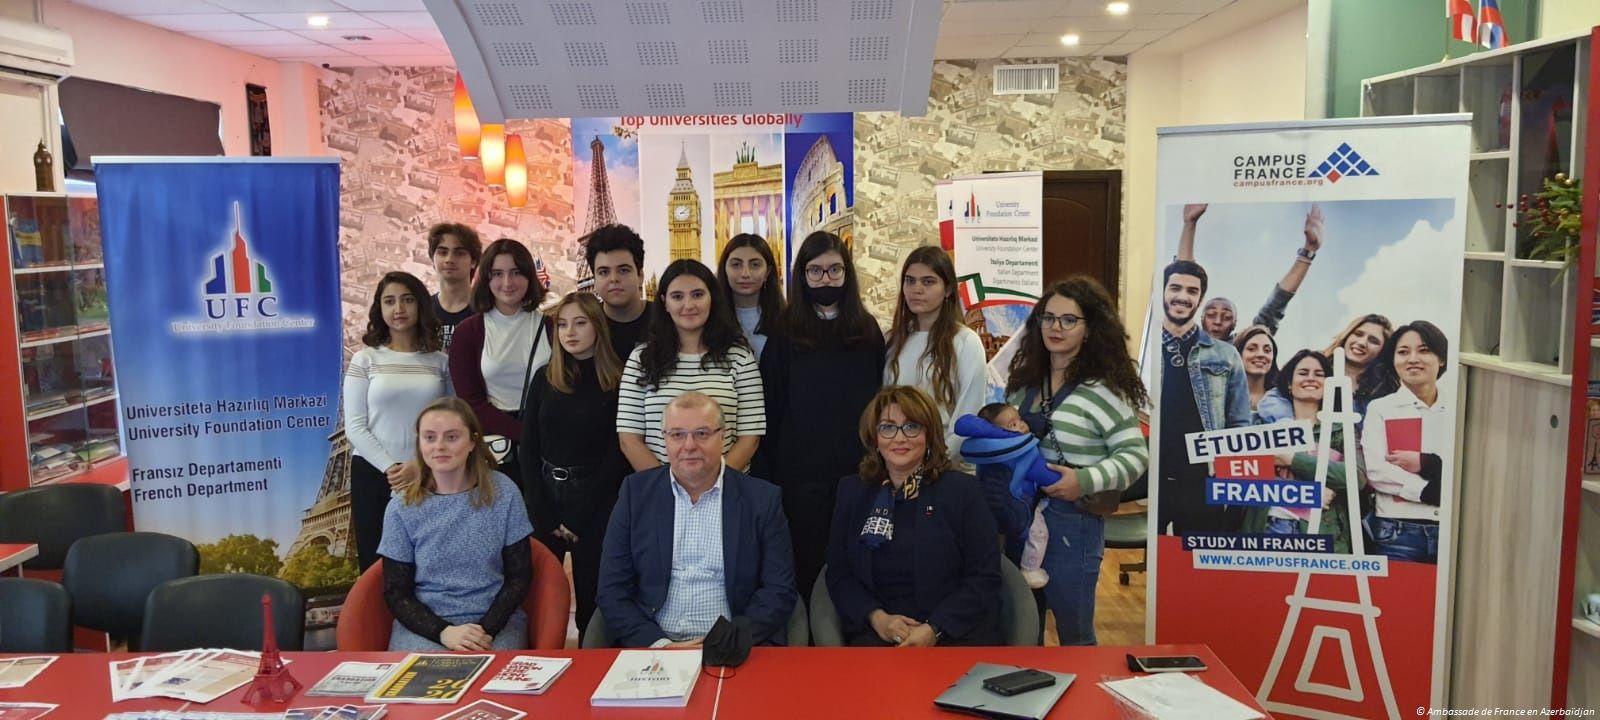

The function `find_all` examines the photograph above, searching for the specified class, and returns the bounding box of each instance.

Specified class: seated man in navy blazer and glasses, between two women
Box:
[597,392,797,648]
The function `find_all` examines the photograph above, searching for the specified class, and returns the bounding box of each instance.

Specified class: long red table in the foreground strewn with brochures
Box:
[0,645,1266,720]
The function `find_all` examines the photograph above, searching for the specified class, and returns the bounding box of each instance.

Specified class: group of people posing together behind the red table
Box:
[344,224,1147,650]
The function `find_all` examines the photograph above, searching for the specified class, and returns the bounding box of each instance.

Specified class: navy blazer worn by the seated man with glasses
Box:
[595,466,796,648]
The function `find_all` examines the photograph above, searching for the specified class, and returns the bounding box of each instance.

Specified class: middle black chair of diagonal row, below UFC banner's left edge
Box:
[61,533,200,650]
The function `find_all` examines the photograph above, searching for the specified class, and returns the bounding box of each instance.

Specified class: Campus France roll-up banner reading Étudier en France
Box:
[1142,115,1469,718]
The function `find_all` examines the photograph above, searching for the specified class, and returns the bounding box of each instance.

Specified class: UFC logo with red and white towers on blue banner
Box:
[171,202,317,334]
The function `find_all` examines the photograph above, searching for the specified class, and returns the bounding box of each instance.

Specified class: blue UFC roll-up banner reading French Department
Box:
[94,158,344,587]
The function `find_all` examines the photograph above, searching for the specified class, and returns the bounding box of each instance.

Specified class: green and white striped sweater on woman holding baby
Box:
[1006,381,1150,494]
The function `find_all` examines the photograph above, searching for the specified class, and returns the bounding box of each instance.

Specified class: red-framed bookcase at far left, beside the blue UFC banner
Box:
[0,194,128,491]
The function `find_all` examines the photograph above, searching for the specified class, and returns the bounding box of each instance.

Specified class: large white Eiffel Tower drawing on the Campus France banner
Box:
[1256,347,1400,720]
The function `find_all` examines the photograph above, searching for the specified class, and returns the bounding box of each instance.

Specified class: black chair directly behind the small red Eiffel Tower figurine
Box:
[141,573,306,653]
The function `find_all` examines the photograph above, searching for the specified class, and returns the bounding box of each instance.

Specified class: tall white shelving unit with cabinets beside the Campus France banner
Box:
[1362,29,1600,707]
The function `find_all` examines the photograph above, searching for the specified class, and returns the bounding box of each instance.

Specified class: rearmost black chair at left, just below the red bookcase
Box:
[0,483,126,570]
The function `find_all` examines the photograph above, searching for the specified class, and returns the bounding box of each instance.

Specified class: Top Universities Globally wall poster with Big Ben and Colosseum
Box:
[562,112,856,290]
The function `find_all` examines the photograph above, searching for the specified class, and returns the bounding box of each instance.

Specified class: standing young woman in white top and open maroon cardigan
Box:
[450,237,550,488]
